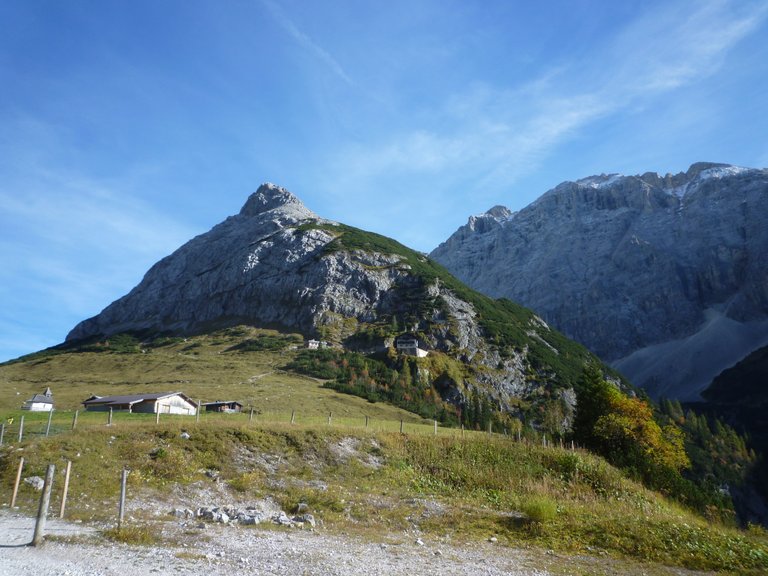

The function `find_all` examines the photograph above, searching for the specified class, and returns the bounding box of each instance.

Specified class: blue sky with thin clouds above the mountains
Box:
[0,0,768,361]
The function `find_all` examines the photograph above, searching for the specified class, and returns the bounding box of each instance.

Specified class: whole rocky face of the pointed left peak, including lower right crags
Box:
[67,184,600,407]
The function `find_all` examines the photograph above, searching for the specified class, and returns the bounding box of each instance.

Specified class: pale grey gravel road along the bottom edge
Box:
[0,509,549,576]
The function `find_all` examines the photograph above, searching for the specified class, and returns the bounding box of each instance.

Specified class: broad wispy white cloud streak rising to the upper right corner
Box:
[328,0,768,194]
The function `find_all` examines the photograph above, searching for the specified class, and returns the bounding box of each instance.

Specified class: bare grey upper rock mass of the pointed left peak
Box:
[67,184,416,340]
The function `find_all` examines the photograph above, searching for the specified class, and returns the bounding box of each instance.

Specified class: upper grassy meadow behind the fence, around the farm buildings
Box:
[0,327,432,422]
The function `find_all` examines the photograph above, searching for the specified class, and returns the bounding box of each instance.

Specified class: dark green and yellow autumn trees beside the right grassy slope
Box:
[573,365,755,522]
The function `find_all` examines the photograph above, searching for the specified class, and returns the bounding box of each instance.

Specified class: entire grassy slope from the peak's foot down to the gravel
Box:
[0,327,768,574]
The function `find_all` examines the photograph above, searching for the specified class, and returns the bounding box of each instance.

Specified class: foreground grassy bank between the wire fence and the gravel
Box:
[0,415,768,574]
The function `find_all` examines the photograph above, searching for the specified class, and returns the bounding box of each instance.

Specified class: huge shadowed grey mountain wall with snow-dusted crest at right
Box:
[431,163,768,399]
